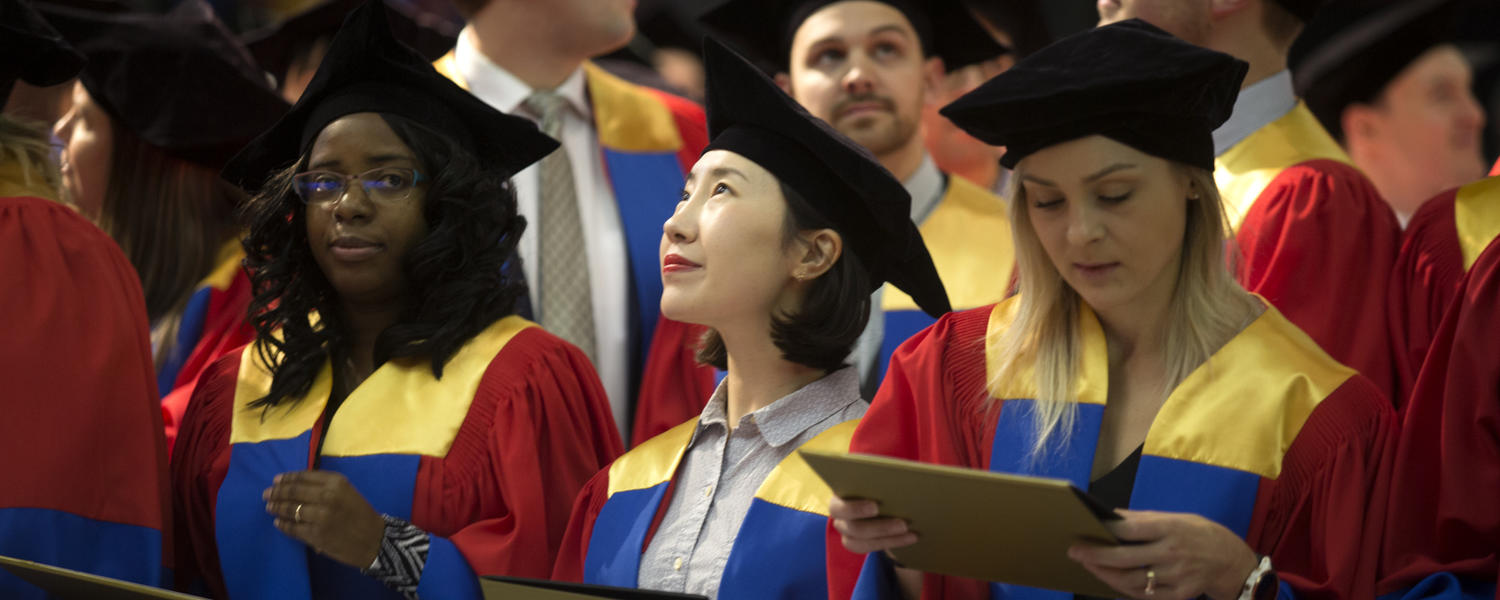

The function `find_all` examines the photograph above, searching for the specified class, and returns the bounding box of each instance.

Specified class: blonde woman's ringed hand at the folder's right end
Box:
[1068,510,1257,600]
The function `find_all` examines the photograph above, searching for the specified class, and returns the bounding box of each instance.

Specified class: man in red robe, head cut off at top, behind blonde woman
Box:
[1098,0,1401,395]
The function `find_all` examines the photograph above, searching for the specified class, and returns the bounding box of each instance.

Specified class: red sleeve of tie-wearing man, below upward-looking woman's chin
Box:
[630,317,714,447]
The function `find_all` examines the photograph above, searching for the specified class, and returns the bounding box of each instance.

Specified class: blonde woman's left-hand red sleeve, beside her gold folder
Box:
[828,306,999,599]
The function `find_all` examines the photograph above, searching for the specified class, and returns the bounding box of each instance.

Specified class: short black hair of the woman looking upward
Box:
[698,183,872,371]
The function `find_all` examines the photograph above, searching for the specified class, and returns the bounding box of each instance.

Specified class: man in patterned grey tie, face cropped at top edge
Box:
[435,0,713,444]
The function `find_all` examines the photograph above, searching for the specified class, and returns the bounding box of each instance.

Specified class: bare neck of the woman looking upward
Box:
[716,318,827,429]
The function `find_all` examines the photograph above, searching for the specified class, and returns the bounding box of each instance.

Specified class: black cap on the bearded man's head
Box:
[702,0,1008,71]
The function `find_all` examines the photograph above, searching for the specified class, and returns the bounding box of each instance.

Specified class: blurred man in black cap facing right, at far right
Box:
[1292,0,1487,224]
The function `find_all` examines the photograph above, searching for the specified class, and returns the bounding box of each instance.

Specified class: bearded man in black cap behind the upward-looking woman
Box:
[687,0,1014,402]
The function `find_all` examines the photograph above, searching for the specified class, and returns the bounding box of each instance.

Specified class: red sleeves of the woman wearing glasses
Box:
[173,327,623,593]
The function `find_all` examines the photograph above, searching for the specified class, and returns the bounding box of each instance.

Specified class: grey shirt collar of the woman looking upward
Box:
[689,366,861,446]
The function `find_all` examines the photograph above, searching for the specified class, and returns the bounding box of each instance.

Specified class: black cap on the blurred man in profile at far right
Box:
[1289,0,1458,140]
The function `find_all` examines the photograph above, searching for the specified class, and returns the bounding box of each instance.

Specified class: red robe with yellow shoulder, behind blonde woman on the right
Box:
[1214,102,1401,398]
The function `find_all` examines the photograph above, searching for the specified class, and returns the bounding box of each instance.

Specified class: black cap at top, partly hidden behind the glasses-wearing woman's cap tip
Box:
[242,0,459,87]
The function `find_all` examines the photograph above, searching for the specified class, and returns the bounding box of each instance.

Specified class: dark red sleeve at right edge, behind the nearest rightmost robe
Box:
[1388,191,1464,407]
